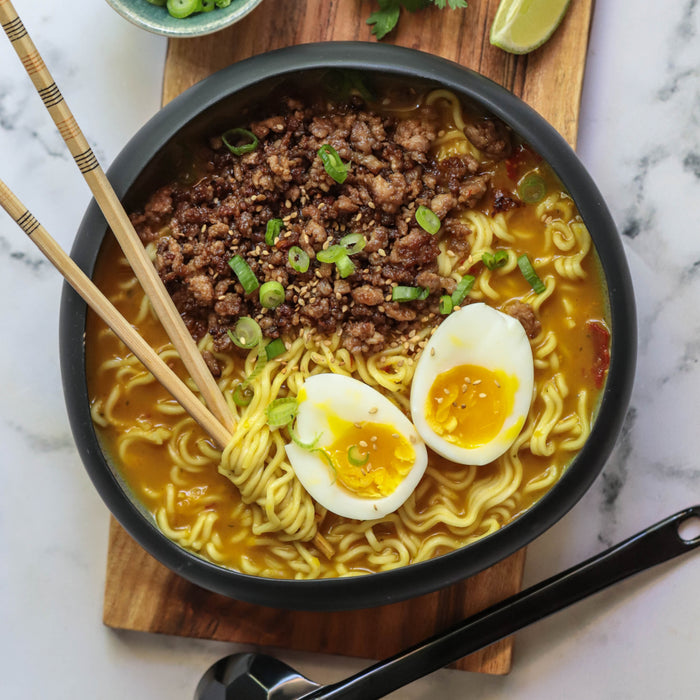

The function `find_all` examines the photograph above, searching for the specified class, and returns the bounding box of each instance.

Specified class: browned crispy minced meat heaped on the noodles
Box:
[132,98,510,358]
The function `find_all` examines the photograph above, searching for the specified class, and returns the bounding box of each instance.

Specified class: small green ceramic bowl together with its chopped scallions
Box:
[107,0,262,38]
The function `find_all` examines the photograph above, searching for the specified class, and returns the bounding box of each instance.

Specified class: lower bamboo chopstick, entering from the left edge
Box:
[0,175,231,449]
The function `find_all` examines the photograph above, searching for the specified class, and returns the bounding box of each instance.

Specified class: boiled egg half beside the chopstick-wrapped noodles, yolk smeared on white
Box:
[286,374,428,520]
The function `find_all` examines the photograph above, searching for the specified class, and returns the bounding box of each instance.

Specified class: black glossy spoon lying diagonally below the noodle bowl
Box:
[194,505,700,700]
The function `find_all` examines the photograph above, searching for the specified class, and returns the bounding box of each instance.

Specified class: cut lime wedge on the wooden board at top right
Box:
[490,0,569,53]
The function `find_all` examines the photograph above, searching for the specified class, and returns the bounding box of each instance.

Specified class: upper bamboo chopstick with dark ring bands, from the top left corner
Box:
[0,0,233,430]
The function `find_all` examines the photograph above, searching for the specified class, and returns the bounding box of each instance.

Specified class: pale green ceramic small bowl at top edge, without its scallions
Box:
[107,0,262,38]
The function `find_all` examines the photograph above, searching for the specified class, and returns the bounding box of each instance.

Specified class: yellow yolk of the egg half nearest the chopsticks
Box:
[322,416,416,498]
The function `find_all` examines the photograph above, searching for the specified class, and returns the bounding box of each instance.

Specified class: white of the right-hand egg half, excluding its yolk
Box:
[410,303,534,465]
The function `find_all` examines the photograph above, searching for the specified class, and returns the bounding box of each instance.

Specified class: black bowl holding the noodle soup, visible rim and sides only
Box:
[60,43,636,610]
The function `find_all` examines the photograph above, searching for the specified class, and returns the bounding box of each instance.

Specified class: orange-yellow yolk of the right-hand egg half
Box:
[425,365,522,449]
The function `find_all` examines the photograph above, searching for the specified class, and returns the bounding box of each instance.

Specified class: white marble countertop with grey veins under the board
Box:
[0,0,700,700]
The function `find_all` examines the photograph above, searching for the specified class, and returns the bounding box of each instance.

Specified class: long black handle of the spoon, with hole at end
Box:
[312,505,700,700]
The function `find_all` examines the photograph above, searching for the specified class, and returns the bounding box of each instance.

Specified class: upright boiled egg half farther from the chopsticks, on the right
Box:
[411,303,534,465]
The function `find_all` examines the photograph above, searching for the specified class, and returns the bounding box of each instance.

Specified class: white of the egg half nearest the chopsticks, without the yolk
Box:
[285,374,428,520]
